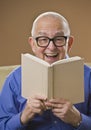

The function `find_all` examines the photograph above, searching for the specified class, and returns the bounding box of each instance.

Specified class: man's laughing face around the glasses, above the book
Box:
[29,17,73,64]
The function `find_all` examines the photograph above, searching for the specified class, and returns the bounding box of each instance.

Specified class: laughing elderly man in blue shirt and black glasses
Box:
[0,12,91,130]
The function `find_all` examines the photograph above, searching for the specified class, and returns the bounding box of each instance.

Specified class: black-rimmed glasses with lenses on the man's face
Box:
[34,36,67,47]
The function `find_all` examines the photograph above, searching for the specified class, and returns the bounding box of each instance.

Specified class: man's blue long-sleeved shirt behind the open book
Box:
[0,65,91,130]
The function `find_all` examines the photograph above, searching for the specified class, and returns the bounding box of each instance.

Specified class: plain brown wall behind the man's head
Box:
[0,0,91,66]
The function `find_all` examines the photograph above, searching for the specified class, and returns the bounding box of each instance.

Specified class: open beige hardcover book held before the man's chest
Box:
[21,53,84,103]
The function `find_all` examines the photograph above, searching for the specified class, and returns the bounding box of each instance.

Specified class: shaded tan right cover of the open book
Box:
[53,60,84,103]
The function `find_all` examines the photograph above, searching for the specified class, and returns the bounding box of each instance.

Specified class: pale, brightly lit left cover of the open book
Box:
[22,54,52,98]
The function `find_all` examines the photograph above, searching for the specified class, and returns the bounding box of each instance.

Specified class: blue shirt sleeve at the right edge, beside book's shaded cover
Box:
[74,66,91,130]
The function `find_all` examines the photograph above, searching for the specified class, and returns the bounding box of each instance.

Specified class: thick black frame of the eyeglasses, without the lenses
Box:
[33,36,68,48]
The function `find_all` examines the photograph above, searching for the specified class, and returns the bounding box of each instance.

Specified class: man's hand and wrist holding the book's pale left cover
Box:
[21,96,46,124]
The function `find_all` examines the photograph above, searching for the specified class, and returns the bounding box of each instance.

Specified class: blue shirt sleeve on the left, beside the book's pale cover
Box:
[0,67,25,130]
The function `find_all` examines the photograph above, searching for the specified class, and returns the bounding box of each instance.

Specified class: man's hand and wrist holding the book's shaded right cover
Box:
[46,99,81,127]
